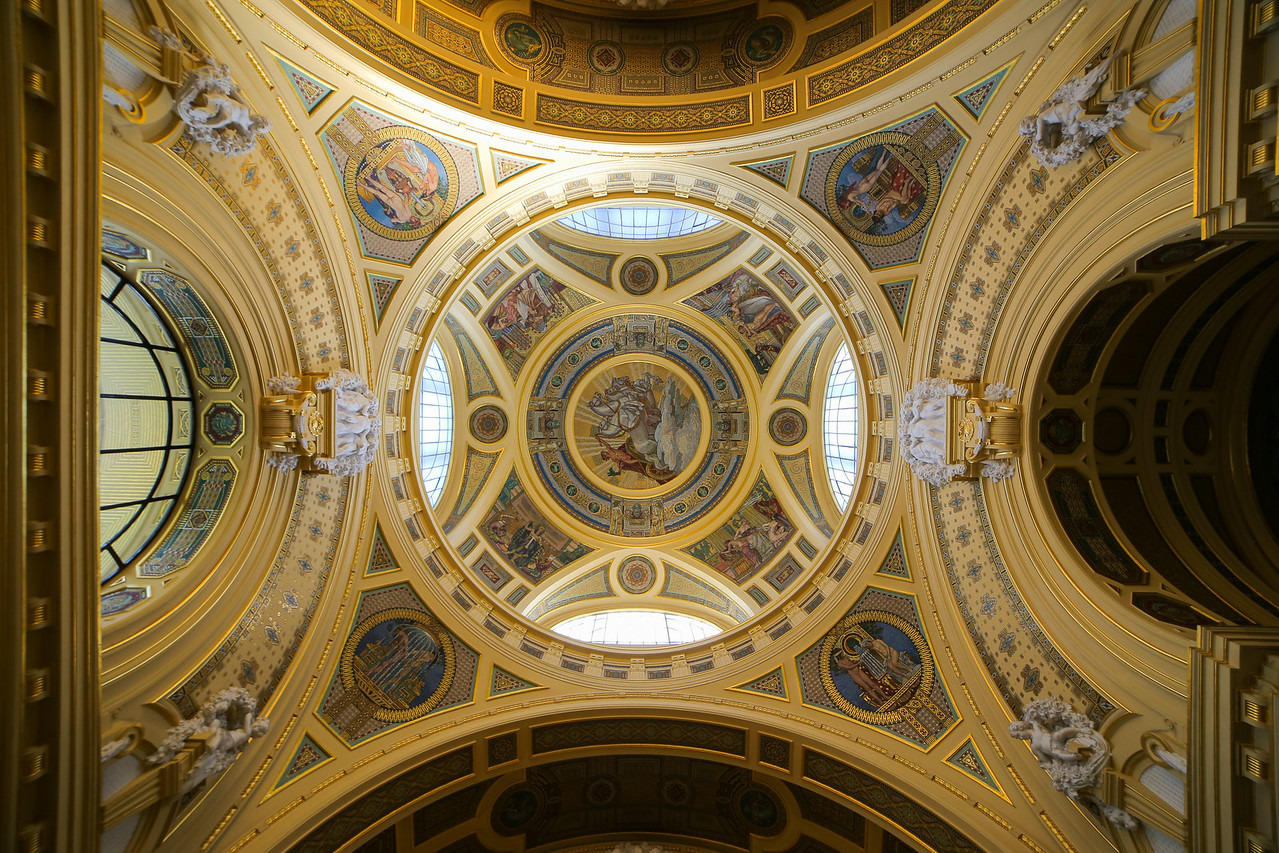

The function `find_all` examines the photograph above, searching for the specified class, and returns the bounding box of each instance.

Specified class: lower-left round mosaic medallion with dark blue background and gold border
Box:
[341,609,454,723]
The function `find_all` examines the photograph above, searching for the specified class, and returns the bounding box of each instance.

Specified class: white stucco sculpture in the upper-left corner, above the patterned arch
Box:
[173,56,271,156]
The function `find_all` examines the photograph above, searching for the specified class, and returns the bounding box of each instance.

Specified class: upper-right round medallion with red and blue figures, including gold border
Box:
[826,132,941,246]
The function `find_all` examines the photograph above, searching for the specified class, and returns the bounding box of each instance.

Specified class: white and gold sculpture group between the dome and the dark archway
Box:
[897,377,1021,486]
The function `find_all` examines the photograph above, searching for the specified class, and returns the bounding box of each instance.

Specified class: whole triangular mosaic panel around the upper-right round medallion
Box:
[799,107,964,270]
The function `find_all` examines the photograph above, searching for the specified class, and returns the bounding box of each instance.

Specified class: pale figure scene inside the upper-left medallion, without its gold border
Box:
[356,139,448,230]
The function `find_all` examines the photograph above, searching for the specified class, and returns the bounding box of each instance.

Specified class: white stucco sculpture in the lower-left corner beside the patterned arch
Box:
[147,687,270,794]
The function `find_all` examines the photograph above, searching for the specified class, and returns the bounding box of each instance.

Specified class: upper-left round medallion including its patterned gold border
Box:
[343,127,458,240]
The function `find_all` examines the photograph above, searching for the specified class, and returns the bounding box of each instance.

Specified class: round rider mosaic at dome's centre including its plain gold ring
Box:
[570,361,706,491]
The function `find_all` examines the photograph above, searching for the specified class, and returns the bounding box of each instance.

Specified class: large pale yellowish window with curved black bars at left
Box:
[97,265,194,582]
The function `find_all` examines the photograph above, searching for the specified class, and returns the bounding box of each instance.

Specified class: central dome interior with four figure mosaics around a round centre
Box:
[423,203,859,645]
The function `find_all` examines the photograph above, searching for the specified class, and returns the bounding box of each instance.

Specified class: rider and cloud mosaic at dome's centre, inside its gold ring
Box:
[587,373,702,483]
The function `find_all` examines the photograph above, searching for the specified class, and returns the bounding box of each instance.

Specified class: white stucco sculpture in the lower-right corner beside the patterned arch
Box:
[1008,698,1137,829]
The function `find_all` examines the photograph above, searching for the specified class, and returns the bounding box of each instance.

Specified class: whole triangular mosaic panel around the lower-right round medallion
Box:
[796,587,959,748]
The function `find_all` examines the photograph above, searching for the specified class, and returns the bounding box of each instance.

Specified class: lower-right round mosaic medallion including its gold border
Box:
[821,610,936,725]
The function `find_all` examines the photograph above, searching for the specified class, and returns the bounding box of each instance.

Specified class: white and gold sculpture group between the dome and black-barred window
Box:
[260,370,382,476]
